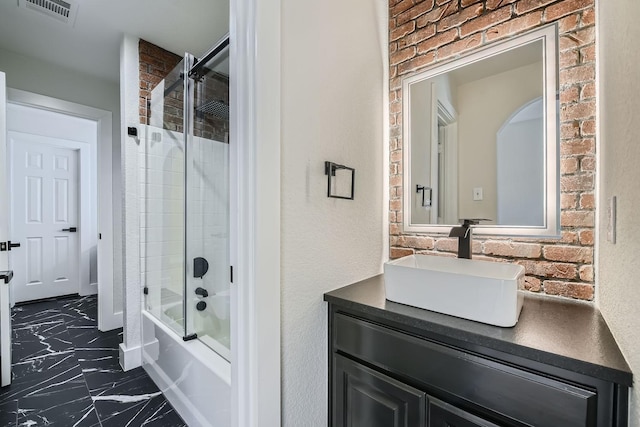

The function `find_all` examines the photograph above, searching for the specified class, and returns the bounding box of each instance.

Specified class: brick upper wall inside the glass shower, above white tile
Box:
[138,39,229,142]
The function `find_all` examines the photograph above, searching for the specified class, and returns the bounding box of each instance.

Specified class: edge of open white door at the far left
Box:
[0,72,12,386]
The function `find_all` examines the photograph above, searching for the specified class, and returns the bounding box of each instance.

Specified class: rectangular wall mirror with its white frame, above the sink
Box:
[402,24,560,238]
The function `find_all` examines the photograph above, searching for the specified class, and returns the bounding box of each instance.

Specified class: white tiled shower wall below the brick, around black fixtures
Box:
[139,126,229,339]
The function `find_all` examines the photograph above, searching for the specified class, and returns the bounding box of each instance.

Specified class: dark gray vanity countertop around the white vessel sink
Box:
[324,275,632,386]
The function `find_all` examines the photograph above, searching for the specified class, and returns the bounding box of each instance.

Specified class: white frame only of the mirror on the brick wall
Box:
[402,23,561,238]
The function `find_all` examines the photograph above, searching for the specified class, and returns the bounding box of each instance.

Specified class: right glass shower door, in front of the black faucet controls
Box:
[185,38,231,360]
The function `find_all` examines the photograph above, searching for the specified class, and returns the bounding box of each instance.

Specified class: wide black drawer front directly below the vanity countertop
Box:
[332,314,600,427]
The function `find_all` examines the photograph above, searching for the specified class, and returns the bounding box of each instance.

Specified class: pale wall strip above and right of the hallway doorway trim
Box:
[0,49,122,311]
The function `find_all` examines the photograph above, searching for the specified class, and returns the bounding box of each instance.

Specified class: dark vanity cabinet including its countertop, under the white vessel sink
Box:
[325,276,631,427]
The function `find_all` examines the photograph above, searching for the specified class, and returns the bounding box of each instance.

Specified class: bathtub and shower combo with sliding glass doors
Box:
[139,37,231,426]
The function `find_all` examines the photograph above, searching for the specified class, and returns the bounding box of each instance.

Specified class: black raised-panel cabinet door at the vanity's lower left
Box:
[333,354,426,427]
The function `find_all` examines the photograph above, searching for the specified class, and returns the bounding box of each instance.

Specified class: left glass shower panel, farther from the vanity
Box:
[139,59,186,336]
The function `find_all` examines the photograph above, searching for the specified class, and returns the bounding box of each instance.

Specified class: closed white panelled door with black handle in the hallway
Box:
[9,138,80,302]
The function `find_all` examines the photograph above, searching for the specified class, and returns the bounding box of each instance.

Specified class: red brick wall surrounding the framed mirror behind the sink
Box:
[389,0,596,300]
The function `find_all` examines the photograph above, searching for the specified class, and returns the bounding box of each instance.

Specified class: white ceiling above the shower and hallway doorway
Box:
[0,0,229,81]
